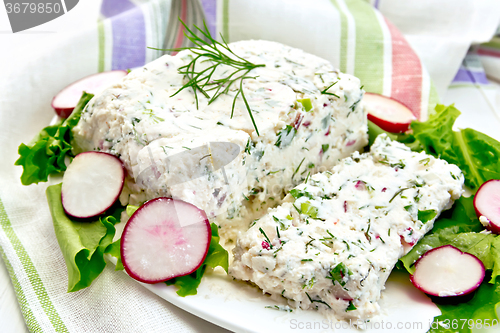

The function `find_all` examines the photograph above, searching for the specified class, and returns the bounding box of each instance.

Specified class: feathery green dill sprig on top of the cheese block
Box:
[153,19,265,135]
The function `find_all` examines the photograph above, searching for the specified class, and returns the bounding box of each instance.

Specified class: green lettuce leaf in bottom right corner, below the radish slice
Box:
[429,276,500,333]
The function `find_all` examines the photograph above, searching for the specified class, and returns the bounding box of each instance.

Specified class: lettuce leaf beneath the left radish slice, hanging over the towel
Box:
[46,184,123,291]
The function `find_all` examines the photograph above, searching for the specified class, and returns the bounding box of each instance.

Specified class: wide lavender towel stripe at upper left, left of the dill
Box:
[101,0,146,70]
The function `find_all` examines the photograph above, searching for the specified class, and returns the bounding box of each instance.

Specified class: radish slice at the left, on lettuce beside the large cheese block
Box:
[61,151,125,218]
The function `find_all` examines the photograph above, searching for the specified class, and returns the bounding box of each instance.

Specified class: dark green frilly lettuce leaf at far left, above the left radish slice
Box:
[15,92,94,185]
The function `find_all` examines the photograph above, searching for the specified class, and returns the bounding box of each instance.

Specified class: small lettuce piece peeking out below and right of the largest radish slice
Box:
[165,223,229,297]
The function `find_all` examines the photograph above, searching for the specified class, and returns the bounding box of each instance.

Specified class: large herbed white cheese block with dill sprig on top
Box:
[74,41,367,239]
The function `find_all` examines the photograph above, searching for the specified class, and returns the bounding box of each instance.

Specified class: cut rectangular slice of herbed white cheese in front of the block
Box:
[230,135,464,320]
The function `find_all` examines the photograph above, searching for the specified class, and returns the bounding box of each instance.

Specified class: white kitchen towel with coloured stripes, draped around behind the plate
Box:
[0,0,496,332]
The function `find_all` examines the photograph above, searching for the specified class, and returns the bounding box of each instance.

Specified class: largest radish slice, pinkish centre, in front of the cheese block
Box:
[120,198,211,283]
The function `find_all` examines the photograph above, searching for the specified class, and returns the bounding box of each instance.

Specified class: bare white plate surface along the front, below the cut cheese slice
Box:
[109,257,441,333]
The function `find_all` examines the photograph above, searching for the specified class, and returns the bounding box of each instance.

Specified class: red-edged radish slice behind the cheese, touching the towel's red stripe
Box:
[363,93,417,133]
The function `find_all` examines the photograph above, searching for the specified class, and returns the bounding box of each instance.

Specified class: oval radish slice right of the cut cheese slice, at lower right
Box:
[410,245,485,297]
